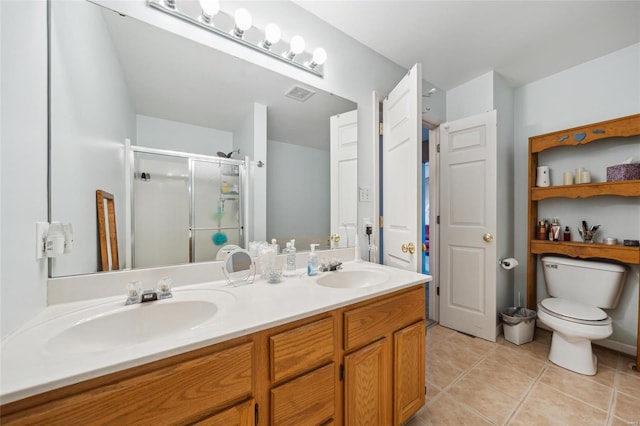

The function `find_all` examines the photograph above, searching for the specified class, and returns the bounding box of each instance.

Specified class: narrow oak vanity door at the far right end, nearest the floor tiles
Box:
[393,321,425,425]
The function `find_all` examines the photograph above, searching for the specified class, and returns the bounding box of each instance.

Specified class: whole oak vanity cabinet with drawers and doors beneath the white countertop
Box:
[0,284,425,426]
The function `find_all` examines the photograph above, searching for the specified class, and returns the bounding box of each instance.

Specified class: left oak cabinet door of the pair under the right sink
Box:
[344,338,391,426]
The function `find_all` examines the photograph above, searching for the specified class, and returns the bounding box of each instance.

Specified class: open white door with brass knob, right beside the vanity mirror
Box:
[382,64,422,272]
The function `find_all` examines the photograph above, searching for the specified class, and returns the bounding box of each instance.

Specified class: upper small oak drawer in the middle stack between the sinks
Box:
[269,317,335,382]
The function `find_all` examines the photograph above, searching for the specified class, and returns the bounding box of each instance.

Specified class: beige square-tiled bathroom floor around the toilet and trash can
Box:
[405,325,640,426]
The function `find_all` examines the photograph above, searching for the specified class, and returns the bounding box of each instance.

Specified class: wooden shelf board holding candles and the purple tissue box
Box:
[531,180,640,201]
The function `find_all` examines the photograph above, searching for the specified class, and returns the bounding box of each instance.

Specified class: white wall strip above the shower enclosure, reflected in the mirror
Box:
[135,114,232,158]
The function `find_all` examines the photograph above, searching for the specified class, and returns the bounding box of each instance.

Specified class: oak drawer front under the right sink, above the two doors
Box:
[344,286,425,351]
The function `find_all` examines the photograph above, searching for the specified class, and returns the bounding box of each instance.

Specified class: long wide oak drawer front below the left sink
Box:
[2,343,253,425]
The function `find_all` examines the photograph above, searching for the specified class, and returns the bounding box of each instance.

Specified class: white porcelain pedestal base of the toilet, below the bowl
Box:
[549,330,598,376]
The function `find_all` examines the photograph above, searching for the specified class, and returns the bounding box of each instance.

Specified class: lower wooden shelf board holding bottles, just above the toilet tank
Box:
[530,240,640,265]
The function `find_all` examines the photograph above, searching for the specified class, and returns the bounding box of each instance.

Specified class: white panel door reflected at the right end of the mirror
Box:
[329,110,358,247]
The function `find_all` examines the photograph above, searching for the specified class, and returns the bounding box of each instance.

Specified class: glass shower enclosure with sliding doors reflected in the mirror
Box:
[130,147,246,268]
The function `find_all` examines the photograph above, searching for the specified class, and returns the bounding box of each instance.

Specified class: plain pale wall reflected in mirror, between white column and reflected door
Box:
[267,140,331,243]
